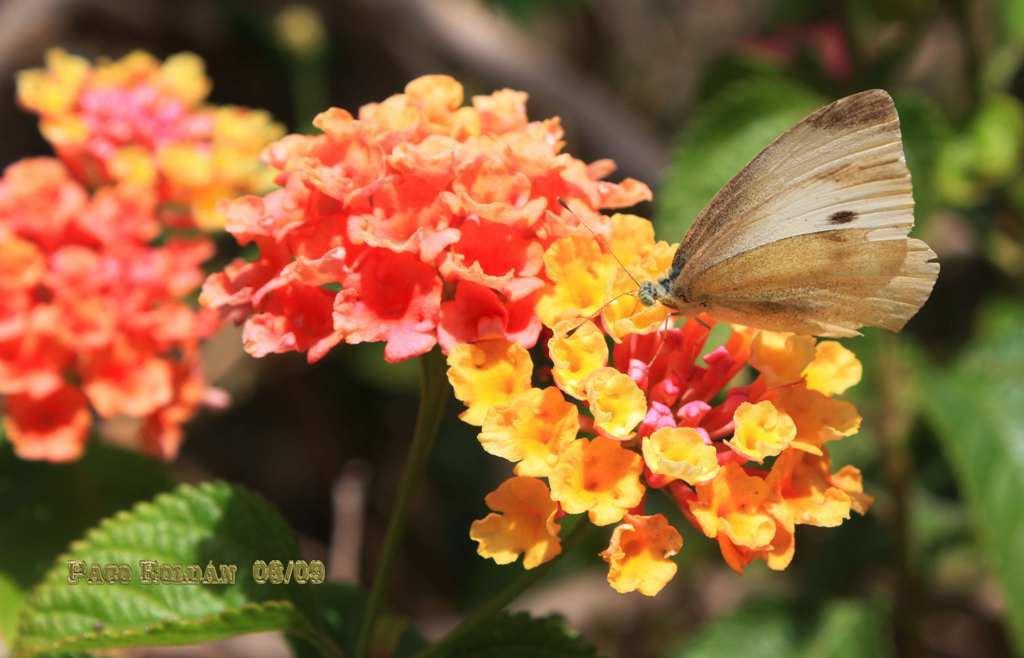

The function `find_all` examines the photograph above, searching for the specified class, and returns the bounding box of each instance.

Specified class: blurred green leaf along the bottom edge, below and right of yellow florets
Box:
[666,601,892,658]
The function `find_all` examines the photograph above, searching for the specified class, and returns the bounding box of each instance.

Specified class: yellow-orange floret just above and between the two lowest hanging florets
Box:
[548,437,644,526]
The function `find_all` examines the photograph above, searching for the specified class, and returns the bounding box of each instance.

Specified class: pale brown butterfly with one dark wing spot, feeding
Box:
[637,89,939,337]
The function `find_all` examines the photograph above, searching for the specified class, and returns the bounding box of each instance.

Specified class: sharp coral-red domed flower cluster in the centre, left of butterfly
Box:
[202,76,650,366]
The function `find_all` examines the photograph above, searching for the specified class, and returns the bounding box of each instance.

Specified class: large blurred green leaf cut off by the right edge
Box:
[916,303,1024,653]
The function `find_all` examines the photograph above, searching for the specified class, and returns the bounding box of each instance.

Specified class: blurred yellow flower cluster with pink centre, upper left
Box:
[17,48,283,229]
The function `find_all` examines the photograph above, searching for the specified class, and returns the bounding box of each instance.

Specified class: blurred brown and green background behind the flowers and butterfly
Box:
[0,0,1024,658]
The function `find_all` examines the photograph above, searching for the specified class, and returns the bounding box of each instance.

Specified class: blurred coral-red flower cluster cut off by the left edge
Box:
[0,158,216,462]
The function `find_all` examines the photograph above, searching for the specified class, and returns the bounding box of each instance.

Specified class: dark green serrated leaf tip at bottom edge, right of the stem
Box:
[444,613,597,658]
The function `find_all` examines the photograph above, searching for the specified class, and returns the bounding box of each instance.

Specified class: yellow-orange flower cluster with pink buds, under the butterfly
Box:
[449,215,871,596]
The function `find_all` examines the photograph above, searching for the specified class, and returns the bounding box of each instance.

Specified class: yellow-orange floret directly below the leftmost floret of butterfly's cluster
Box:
[479,386,580,477]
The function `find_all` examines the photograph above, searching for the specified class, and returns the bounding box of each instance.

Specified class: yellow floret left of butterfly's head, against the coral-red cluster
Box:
[537,235,618,327]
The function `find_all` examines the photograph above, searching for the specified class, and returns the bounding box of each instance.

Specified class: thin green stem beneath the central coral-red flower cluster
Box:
[355,348,451,658]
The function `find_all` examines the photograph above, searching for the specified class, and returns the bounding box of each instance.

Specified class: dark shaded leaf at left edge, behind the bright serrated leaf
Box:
[0,441,173,639]
